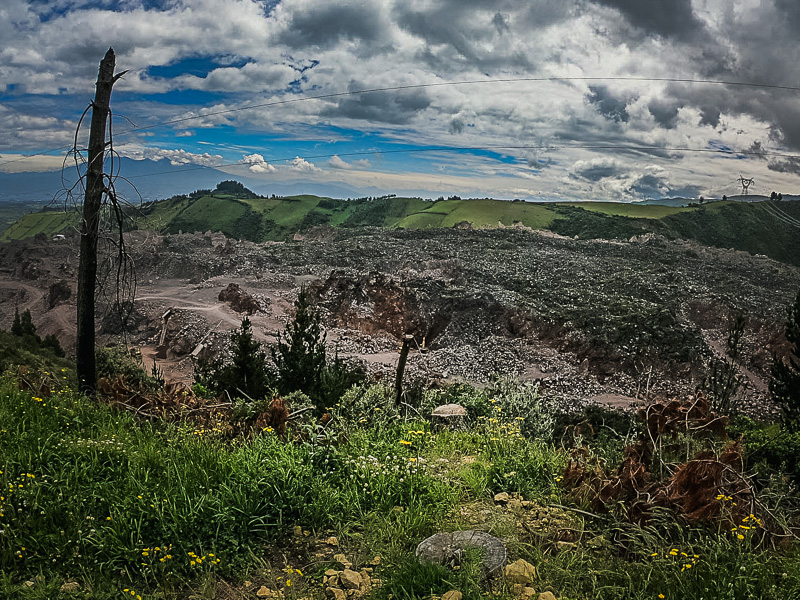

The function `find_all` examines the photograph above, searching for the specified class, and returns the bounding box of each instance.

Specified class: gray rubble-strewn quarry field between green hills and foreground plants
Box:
[0,228,800,416]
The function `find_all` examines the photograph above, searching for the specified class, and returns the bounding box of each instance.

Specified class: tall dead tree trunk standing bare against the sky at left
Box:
[75,48,116,395]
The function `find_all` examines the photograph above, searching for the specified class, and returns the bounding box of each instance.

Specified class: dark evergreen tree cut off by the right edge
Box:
[769,291,800,431]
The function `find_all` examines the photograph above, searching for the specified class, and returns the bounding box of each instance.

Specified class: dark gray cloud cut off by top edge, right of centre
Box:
[595,0,703,38]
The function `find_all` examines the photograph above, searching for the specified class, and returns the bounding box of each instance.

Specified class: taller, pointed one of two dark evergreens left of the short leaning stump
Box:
[272,288,326,400]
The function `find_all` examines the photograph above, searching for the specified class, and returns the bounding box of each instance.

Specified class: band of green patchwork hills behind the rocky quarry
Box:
[0,182,800,265]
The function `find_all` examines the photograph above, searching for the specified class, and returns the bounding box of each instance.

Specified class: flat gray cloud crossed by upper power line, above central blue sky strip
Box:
[320,84,431,125]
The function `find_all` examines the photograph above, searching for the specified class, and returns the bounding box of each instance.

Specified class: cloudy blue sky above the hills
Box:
[0,0,800,202]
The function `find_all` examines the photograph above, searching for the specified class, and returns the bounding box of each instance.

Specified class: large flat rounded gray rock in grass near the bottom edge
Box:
[416,530,506,575]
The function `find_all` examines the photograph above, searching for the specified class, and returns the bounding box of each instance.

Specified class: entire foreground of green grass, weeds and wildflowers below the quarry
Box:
[0,338,800,599]
